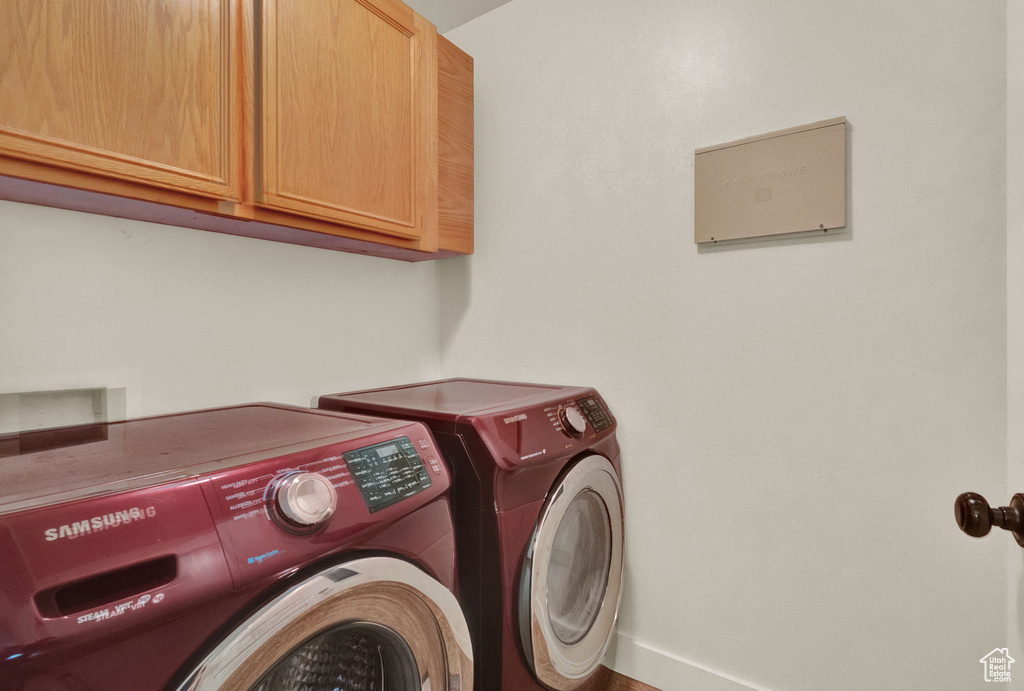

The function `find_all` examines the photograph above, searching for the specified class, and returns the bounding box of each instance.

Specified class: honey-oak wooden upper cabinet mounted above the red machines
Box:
[0,0,473,261]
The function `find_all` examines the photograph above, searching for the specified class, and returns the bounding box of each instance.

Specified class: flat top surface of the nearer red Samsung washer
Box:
[0,403,401,513]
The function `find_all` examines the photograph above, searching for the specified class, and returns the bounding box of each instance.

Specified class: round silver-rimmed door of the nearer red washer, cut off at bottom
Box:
[179,557,473,691]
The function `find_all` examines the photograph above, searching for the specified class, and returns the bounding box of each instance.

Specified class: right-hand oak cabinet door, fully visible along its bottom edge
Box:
[255,0,437,250]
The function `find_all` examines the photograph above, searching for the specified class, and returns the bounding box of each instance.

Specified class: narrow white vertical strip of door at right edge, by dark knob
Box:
[1007,0,1024,689]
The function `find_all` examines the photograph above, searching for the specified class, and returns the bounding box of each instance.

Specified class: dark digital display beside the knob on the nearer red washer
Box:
[341,437,433,513]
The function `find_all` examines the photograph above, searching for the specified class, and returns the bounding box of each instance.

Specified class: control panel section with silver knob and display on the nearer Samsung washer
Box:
[202,421,452,588]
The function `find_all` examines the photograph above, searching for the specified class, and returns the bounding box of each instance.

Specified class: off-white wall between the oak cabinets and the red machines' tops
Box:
[0,202,438,417]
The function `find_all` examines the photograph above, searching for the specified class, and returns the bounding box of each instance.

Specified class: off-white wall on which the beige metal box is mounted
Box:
[440,0,1007,689]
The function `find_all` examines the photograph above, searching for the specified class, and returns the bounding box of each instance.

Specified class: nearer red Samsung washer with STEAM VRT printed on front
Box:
[0,403,473,691]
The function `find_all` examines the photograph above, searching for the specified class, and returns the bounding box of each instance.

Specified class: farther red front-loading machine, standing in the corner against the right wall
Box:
[319,379,623,691]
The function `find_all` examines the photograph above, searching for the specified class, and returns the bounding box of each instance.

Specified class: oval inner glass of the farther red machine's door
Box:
[548,489,611,645]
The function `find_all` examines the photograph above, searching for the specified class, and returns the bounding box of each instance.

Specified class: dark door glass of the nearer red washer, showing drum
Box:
[250,621,420,691]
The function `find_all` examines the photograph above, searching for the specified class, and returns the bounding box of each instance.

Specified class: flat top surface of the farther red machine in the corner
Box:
[319,379,593,418]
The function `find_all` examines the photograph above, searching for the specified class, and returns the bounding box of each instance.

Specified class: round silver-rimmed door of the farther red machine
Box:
[519,455,623,691]
